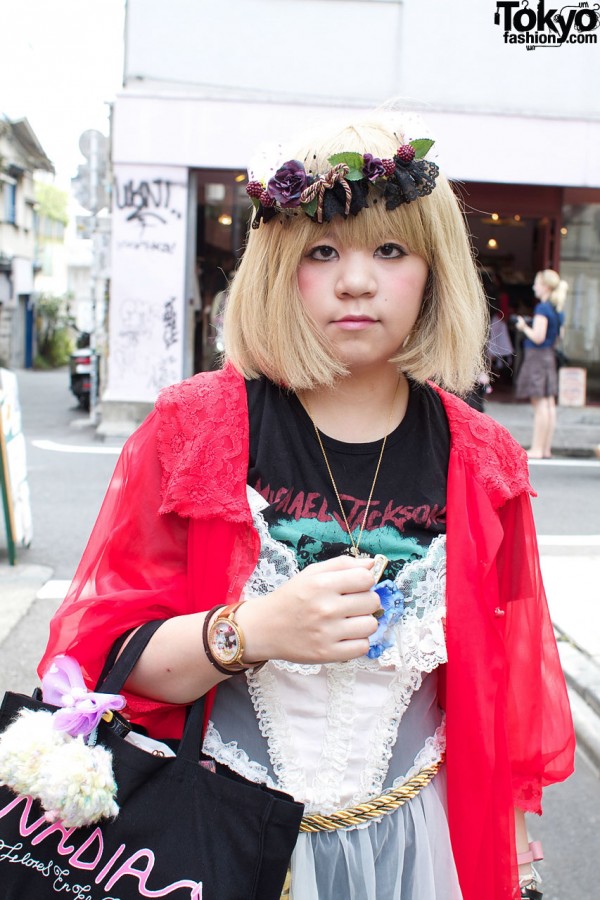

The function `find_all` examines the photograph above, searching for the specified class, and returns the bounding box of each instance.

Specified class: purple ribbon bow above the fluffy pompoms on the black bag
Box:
[42,656,126,737]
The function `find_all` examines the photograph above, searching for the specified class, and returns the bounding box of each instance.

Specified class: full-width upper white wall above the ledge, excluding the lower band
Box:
[125,0,600,118]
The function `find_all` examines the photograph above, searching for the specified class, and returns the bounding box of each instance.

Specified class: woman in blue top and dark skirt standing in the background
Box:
[515,269,568,459]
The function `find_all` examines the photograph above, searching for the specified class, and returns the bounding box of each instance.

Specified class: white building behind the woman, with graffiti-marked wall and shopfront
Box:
[102,0,600,432]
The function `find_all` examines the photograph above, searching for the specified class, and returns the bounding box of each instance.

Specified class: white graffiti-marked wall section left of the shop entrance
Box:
[109,166,187,401]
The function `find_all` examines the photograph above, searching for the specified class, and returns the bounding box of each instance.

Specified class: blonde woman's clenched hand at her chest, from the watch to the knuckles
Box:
[236,556,380,663]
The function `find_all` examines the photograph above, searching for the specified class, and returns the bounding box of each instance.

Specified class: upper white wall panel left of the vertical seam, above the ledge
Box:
[125,0,404,103]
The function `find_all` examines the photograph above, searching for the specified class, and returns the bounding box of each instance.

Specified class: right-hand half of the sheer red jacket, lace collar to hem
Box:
[442,395,575,900]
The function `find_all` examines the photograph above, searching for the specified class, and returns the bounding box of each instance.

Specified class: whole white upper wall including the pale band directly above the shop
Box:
[119,0,600,187]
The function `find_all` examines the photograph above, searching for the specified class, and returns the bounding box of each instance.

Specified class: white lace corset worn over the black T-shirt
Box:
[204,488,446,813]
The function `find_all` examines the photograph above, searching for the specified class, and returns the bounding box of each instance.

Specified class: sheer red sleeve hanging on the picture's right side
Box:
[498,494,575,813]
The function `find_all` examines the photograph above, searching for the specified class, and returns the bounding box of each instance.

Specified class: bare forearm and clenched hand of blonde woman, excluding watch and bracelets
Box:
[126,556,380,703]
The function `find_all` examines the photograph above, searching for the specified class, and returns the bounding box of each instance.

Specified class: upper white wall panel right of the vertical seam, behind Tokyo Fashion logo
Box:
[399,0,600,119]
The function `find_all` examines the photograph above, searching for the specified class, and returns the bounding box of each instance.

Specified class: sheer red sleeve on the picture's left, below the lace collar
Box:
[38,412,190,721]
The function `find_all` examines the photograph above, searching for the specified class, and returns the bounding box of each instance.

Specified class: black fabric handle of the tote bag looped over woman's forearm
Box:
[96,619,204,762]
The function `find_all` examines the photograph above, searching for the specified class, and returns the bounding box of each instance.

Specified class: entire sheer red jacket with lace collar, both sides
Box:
[39,367,574,900]
